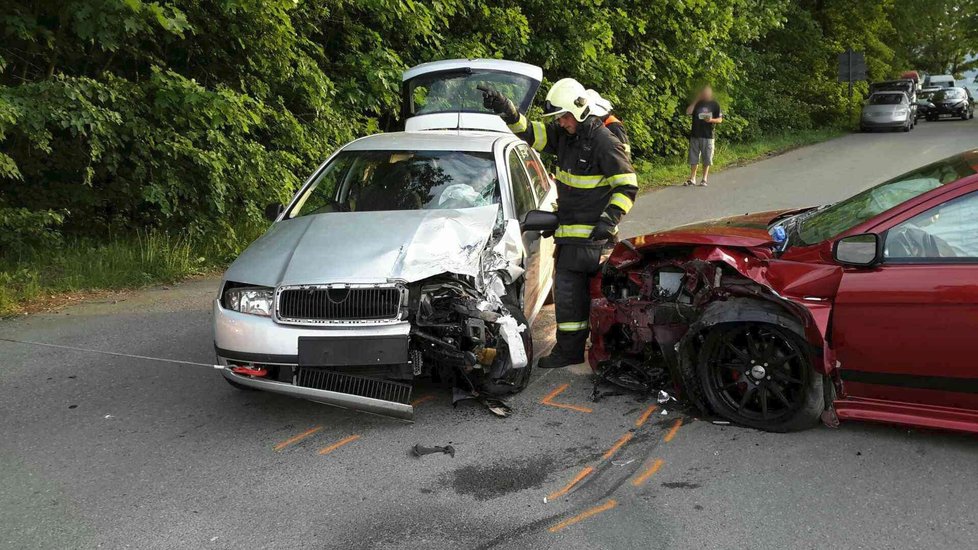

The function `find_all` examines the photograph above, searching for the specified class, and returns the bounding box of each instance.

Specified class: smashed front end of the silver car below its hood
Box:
[214,213,532,420]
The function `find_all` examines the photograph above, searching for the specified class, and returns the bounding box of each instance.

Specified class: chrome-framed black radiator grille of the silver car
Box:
[276,285,403,323]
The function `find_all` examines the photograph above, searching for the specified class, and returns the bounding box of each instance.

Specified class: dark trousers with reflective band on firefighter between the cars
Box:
[554,246,601,357]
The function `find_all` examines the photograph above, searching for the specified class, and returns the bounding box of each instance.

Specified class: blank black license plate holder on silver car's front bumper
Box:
[299,336,408,367]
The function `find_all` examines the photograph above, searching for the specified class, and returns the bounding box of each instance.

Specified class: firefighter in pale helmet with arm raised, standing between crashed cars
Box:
[480,78,638,368]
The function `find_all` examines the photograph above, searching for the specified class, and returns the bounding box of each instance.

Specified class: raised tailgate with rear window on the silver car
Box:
[401,59,543,132]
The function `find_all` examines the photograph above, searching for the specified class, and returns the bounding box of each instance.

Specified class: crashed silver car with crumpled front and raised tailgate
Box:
[214,60,556,419]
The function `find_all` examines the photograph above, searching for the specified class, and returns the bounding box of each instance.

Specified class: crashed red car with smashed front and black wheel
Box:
[588,150,978,432]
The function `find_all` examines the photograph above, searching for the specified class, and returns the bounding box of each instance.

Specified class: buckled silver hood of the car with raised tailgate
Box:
[224,205,499,287]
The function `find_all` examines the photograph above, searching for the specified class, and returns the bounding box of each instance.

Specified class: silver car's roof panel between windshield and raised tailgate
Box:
[343,130,516,153]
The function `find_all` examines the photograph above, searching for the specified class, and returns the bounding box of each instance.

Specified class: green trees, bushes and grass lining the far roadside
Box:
[0,0,978,314]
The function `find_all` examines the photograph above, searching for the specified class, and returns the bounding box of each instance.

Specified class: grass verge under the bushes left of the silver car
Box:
[0,226,258,317]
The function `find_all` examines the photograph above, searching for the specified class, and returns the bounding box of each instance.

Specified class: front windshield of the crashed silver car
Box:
[289,151,499,218]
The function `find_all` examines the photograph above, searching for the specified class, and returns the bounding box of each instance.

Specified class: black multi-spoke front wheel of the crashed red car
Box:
[697,323,823,432]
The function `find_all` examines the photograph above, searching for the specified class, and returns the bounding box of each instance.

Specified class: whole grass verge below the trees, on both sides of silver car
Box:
[0,128,846,317]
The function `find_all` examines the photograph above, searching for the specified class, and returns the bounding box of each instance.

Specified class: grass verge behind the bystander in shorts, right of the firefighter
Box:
[636,128,849,189]
